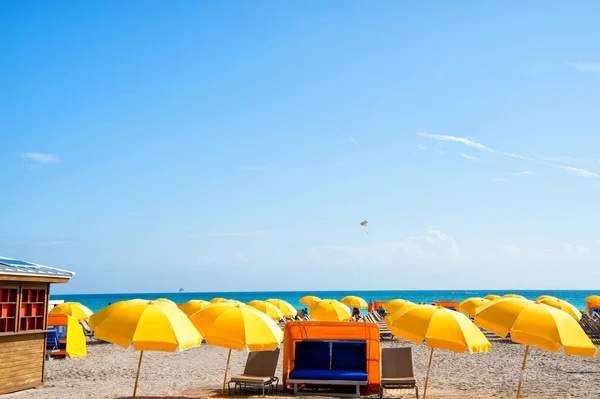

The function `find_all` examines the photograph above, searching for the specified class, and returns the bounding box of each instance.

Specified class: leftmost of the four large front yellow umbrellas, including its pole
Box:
[89,300,202,398]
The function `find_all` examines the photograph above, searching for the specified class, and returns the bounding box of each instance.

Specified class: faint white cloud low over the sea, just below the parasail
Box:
[310,229,460,265]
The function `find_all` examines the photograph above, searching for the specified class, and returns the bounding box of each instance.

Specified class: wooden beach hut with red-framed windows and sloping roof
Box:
[0,257,75,394]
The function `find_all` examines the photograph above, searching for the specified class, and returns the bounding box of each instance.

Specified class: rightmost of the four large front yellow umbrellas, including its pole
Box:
[475,298,596,399]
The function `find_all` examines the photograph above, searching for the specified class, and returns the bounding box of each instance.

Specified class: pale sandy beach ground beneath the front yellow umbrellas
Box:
[4,339,600,399]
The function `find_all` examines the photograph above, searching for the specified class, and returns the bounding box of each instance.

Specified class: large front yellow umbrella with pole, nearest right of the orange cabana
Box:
[385,305,491,399]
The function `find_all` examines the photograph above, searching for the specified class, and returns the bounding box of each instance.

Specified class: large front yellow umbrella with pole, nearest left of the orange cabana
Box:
[190,302,283,392]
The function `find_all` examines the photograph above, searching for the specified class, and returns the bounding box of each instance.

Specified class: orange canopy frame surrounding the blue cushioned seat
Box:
[283,321,381,394]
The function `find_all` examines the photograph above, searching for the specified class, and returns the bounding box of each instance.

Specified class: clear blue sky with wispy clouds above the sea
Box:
[0,1,600,293]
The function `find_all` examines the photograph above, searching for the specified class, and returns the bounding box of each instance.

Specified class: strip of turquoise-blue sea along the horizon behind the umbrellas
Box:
[50,290,600,312]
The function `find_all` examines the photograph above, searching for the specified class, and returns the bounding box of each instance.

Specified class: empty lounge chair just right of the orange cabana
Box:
[379,348,419,399]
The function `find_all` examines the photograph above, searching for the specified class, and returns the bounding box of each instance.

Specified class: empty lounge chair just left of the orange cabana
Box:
[227,348,280,396]
